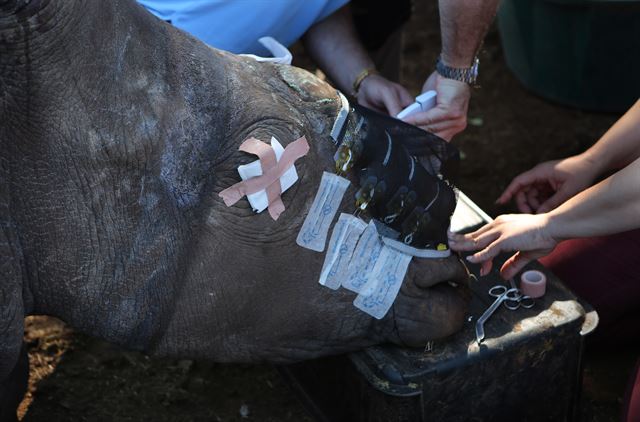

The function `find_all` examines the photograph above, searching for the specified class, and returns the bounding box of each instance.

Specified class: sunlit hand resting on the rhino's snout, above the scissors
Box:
[449,214,558,279]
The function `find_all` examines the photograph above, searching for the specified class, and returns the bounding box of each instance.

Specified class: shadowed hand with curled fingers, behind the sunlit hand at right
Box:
[496,155,599,214]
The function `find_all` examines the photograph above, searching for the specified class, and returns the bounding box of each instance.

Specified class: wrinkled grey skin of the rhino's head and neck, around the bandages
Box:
[0,0,467,418]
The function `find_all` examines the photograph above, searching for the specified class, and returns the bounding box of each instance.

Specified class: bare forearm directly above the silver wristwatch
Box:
[439,0,499,67]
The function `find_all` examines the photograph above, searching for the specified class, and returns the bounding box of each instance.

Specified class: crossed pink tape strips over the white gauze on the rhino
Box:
[218,136,309,220]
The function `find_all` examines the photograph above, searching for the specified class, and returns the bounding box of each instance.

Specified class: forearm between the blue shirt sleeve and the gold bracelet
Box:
[303,6,374,93]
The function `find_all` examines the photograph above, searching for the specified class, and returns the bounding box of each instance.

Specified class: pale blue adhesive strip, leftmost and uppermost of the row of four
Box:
[296,171,350,252]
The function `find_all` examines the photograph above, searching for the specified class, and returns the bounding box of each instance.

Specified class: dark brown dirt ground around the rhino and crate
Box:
[20,1,640,422]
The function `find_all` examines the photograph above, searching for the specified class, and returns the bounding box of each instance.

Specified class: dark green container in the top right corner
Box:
[498,0,640,112]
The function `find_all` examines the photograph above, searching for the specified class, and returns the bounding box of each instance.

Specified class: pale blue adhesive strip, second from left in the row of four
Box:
[319,213,367,290]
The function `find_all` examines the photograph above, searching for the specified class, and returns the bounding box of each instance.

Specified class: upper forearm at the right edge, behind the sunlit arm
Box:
[581,101,640,173]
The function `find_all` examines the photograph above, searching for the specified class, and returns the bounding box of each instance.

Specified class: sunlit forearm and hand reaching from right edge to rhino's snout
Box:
[449,159,640,279]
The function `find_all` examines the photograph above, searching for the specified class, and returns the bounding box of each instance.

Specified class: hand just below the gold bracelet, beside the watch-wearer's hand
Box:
[357,74,414,117]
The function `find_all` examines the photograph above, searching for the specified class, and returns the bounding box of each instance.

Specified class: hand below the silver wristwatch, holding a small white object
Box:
[404,72,471,141]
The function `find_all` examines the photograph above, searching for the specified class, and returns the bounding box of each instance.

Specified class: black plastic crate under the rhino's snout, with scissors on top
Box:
[280,195,597,422]
